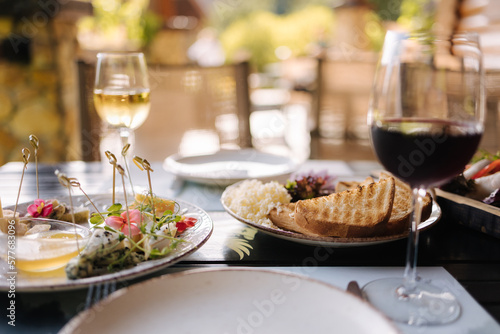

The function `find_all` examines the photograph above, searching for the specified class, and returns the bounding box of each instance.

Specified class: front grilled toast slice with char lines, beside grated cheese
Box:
[294,178,395,237]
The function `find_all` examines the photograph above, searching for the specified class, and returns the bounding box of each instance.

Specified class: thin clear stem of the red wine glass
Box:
[404,188,427,293]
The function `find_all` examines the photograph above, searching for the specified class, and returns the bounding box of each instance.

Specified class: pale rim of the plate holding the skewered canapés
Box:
[0,195,213,291]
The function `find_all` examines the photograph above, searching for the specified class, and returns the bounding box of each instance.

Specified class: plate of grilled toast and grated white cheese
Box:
[221,174,441,247]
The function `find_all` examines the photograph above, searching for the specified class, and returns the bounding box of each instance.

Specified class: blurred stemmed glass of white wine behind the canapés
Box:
[94,52,150,158]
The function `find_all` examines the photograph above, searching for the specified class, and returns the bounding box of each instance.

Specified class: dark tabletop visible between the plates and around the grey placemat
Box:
[0,162,500,333]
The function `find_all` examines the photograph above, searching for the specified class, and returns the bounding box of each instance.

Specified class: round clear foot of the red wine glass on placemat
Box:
[363,278,461,326]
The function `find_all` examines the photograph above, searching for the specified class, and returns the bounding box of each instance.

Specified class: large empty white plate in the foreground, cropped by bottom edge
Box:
[59,268,399,334]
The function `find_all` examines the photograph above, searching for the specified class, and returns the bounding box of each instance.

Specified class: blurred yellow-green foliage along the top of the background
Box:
[70,0,434,69]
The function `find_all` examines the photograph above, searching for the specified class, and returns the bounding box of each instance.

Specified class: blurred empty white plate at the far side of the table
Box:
[163,149,298,186]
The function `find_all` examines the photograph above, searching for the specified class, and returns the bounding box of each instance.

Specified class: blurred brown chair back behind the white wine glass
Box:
[78,61,251,161]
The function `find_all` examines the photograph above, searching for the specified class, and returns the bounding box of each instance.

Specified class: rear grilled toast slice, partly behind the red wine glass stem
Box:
[380,171,432,235]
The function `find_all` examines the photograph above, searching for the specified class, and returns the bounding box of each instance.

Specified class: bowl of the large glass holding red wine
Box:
[368,31,484,188]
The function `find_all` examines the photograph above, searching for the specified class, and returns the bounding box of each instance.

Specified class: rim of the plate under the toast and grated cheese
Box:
[221,183,441,248]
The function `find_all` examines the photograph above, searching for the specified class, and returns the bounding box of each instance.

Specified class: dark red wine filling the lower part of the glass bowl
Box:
[371,118,482,187]
